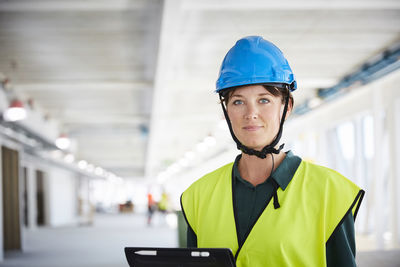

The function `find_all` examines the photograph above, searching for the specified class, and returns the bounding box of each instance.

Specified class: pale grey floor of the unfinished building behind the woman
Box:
[0,214,400,267]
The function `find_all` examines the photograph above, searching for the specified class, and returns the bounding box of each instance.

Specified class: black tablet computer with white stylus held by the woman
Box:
[125,247,236,267]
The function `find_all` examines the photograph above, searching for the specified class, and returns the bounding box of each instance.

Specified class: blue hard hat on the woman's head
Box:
[216,36,297,93]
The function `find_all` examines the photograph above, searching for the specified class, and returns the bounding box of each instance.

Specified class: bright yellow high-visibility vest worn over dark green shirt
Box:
[181,161,364,267]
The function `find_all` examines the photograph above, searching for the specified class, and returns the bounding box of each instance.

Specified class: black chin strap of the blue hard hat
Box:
[219,88,289,159]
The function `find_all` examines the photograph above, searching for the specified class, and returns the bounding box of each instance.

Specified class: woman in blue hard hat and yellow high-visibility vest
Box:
[181,36,364,267]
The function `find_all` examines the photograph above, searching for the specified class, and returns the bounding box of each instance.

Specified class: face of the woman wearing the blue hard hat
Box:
[227,85,291,151]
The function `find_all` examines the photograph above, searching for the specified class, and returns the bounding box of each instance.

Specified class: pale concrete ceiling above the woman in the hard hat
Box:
[0,0,400,178]
